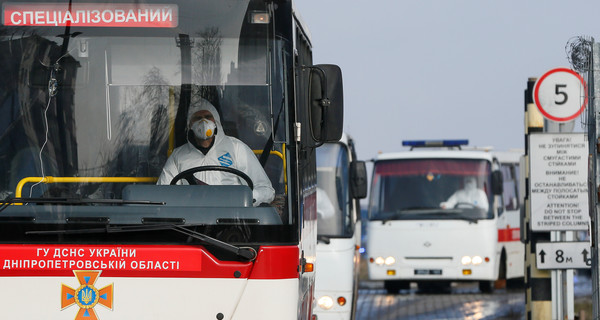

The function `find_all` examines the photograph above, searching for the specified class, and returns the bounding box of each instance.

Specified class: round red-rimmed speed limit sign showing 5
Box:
[533,68,587,122]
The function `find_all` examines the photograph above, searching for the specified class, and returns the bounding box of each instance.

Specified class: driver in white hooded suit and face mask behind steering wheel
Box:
[157,98,275,206]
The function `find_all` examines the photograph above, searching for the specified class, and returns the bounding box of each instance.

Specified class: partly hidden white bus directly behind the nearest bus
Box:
[314,134,367,320]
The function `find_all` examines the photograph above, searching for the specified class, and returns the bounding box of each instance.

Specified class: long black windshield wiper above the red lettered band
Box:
[25,224,257,261]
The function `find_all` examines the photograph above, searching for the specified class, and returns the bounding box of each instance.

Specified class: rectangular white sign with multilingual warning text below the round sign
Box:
[529,133,589,231]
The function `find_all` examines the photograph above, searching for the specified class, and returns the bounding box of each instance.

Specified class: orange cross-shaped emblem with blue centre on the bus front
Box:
[60,270,113,320]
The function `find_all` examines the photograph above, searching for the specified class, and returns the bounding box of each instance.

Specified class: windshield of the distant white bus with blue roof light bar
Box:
[369,159,494,221]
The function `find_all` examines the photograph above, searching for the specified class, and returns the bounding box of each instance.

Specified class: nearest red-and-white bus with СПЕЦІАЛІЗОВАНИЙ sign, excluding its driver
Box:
[0,0,343,320]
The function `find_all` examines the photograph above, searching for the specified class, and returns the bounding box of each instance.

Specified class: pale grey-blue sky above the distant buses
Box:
[295,0,600,160]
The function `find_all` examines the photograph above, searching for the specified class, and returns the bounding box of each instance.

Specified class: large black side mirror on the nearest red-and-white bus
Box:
[308,64,344,143]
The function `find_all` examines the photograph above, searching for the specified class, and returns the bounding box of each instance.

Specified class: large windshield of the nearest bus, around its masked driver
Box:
[0,0,294,242]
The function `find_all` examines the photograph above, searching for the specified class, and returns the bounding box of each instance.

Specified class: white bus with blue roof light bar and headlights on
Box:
[366,140,512,293]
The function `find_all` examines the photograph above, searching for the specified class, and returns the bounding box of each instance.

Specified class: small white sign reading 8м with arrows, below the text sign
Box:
[535,242,592,270]
